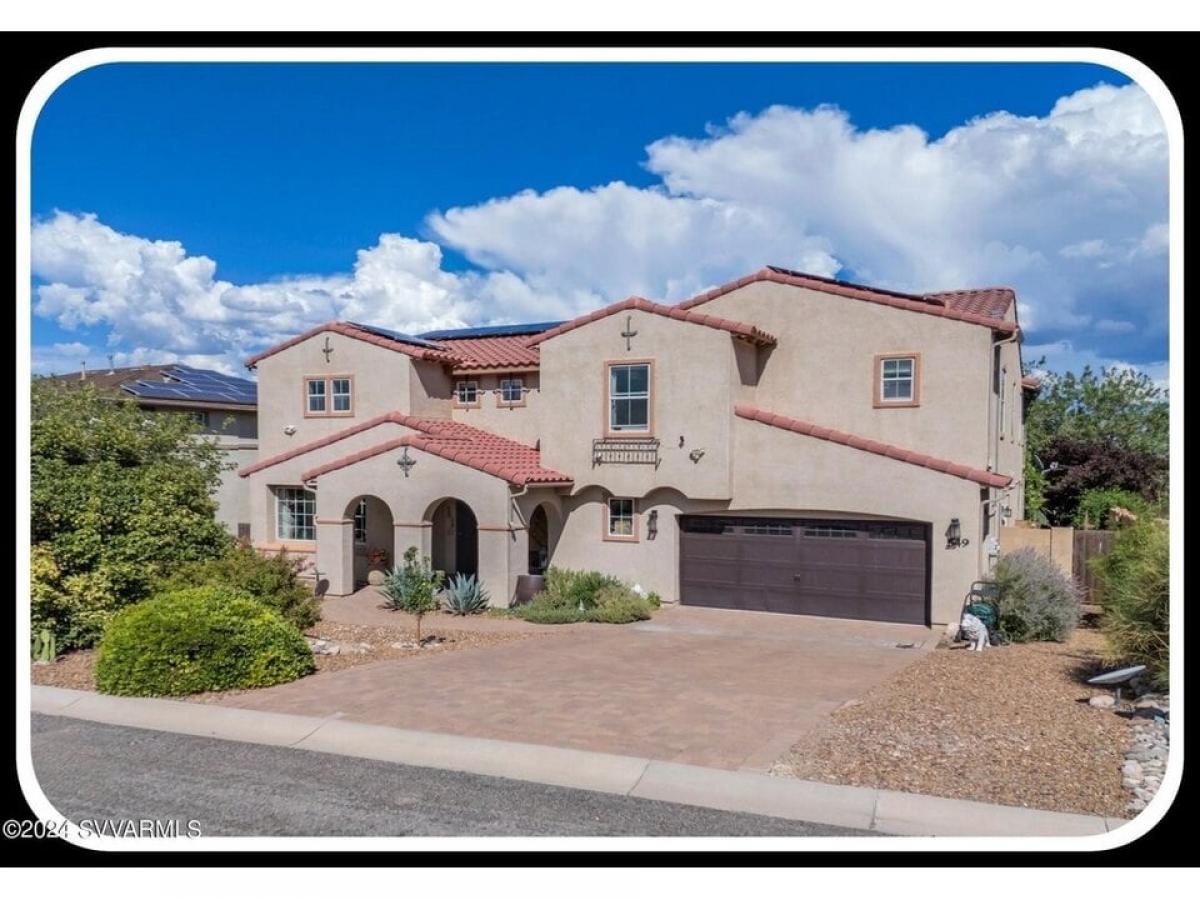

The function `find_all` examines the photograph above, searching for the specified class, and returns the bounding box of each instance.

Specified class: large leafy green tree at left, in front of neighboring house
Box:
[30,379,233,649]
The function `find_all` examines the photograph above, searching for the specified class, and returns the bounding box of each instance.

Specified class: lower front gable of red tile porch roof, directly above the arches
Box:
[301,422,571,485]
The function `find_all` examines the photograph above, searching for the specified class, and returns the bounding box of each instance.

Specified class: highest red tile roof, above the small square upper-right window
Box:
[676,266,1016,332]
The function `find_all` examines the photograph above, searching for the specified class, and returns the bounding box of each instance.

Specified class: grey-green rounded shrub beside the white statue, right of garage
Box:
[991,547,1080,643]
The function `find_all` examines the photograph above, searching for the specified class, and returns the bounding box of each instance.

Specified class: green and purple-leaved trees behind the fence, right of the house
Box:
[1025,361,1170,524]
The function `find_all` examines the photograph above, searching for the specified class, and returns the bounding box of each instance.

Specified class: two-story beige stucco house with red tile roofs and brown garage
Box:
[241,268,1033,624]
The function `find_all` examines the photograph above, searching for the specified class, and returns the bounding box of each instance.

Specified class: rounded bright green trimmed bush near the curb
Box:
[96,586,313,696]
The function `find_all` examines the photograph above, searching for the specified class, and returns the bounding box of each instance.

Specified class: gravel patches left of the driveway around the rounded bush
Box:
[32,617,553,703]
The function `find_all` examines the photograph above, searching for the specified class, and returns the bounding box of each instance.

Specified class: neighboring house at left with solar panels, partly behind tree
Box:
[42,364,258,538]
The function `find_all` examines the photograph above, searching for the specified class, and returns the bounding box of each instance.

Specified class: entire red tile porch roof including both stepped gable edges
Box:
[238,413,571,485]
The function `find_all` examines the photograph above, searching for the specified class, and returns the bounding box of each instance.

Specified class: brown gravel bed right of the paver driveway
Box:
[772,628,1133,817]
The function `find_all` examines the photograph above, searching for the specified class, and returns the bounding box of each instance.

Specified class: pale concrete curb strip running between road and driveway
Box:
[30,685,1126,838]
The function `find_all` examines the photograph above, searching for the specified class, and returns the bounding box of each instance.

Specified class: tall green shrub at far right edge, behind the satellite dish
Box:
[1090,520,1170,688]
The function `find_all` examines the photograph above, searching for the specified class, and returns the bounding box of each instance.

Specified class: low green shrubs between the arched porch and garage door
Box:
[512,568,658,625]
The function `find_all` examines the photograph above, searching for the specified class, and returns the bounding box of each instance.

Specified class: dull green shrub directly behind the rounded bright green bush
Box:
[158,542,320,631]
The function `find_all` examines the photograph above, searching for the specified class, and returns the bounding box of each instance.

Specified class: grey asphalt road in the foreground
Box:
[32,714,866,836]
